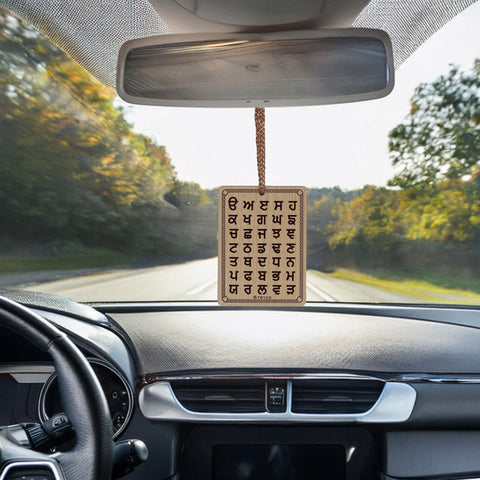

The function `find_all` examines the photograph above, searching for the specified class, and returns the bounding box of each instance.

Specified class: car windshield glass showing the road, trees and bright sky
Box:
[0,3,480,304]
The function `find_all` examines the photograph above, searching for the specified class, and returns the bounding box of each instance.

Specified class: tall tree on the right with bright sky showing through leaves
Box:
[388,60,480,188]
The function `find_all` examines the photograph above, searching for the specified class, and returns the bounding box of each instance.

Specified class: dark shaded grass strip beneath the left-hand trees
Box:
[0,250,132,273]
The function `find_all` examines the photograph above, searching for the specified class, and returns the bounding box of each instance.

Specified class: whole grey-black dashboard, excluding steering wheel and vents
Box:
[0,292,480,480]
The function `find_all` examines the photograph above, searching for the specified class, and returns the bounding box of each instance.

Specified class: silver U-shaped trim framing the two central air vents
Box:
[139,377,417,423]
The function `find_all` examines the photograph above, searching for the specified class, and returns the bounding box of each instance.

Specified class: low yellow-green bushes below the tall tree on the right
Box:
[328,176,480,272]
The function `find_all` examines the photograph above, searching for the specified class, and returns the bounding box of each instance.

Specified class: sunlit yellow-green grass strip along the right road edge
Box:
[324,268,480,305]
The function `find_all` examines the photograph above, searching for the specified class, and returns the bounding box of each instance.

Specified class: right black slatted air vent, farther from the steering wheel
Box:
[292,380,384,414]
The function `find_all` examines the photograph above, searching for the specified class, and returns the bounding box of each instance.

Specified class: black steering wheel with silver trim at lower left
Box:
[0,296,113,480]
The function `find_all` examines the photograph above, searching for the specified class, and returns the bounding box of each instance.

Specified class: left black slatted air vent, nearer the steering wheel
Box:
[171,380,265,413]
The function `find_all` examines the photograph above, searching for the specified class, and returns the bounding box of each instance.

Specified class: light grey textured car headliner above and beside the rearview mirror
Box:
[0,0,475,86]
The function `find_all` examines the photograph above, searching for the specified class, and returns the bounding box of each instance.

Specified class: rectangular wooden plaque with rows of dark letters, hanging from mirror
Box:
[218,187,307,306]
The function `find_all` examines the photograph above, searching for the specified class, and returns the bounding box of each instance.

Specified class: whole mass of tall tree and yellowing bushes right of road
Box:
[320,60,480,276]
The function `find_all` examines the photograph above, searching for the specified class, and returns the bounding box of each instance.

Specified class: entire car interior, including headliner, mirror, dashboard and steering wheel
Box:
[0,0,480,480]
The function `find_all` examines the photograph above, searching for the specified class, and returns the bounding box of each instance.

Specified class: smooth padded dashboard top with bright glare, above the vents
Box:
[111,309,480,374]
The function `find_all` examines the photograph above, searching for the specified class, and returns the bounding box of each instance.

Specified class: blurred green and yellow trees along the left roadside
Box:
[0,9,216,262]
